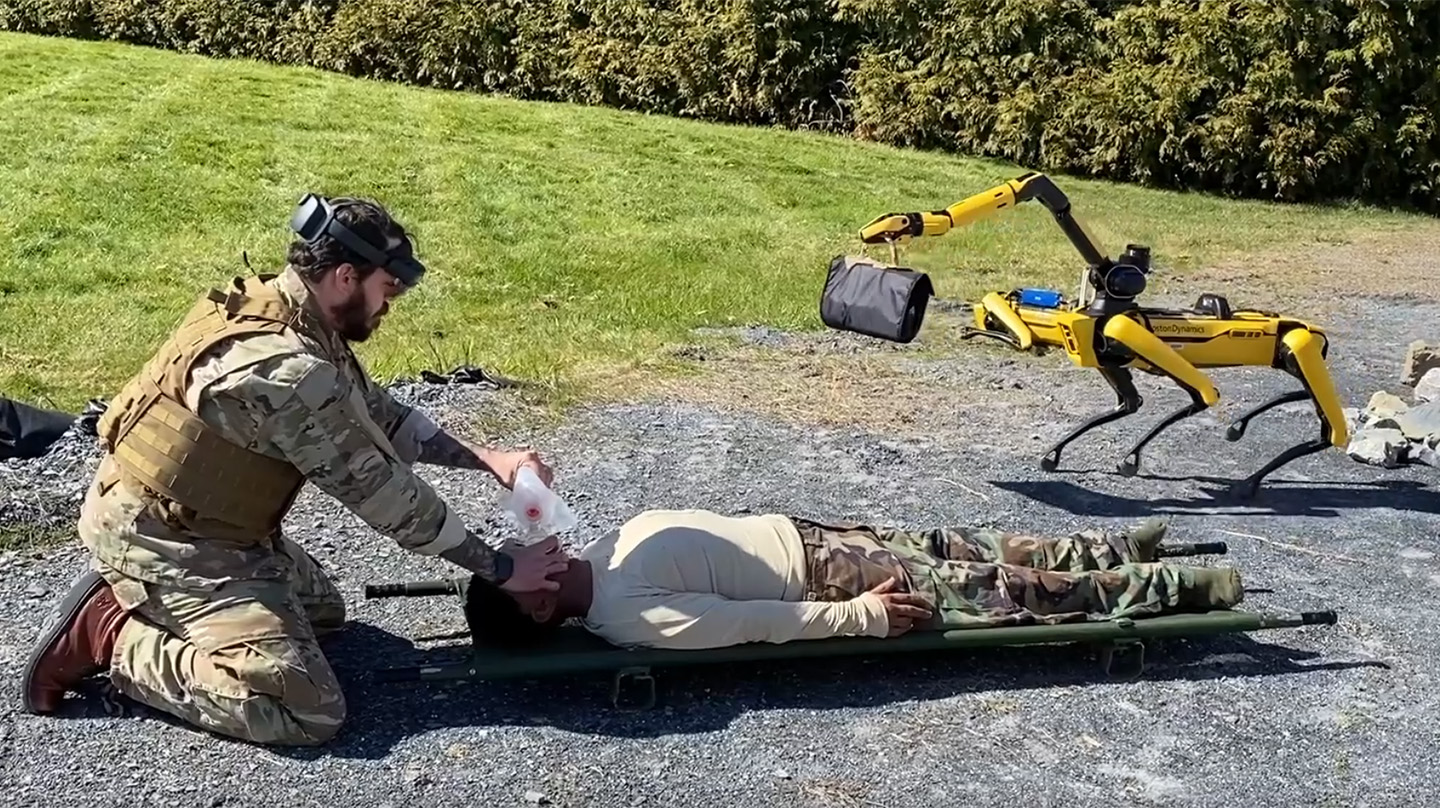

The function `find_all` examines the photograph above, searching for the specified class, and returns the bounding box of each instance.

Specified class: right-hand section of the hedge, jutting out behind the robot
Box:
[847,0,1440,210]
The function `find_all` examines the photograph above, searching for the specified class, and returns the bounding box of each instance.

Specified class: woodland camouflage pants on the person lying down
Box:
[793,519,1240,631]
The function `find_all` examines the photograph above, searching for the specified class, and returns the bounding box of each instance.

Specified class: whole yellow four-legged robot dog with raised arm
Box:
[860,173,1349,498]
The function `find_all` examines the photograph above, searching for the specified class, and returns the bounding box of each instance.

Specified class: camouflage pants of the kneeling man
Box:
[99,539,346,745]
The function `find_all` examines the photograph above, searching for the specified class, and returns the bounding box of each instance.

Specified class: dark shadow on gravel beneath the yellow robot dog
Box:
[989,472,1440,517]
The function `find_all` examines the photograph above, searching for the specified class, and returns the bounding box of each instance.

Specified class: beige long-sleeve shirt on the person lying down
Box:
[580,510,888,648]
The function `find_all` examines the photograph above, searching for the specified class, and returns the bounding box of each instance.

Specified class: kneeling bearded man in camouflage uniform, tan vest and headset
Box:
[23,196,564,745]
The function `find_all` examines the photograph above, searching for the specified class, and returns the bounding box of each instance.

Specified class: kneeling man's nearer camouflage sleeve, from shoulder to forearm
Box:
[225,354,468,556]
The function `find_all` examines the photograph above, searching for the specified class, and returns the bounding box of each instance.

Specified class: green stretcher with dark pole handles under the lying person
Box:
[366,543,1338,709]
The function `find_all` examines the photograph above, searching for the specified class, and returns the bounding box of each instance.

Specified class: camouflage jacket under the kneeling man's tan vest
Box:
[79,269,467,589]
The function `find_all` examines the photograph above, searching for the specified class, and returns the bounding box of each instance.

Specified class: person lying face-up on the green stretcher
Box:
[465,510,1243,648]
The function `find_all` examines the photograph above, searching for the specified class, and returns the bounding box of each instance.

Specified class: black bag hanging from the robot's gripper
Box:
[819,255,935,343]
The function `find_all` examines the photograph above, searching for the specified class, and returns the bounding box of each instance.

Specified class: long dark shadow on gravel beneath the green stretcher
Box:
[250,624,1388,759]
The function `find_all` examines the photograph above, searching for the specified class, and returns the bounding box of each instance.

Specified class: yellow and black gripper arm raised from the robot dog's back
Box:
[860,171,1110,269]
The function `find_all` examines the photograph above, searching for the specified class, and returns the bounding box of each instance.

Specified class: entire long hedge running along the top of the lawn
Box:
[0,0,1440,212]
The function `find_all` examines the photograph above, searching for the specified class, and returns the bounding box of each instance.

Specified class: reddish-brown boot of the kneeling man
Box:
[20,572,130,713]
